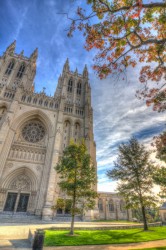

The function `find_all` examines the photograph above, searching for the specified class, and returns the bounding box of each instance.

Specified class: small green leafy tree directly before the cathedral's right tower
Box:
[55,141,97,235]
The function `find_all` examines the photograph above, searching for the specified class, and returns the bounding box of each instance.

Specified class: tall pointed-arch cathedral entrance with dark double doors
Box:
[3,167,37,214]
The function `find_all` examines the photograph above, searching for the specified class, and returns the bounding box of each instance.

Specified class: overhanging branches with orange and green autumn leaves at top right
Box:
[68,0,166,111]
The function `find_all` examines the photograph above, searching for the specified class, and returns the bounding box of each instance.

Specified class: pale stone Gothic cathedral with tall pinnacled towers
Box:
[0,41,131,220]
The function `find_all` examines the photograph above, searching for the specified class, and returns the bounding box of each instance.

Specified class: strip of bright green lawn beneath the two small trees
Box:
[44,227,166,246]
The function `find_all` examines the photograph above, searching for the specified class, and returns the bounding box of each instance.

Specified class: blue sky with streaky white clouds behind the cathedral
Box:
[0,0,166,192]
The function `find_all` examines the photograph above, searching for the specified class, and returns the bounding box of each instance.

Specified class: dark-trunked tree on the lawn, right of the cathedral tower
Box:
[107,138,156,230]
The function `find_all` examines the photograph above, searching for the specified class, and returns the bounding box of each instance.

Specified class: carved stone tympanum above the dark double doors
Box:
[10,175,31,191]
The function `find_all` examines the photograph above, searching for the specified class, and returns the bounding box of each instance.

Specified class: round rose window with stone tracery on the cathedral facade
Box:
[22,121,45,143]
